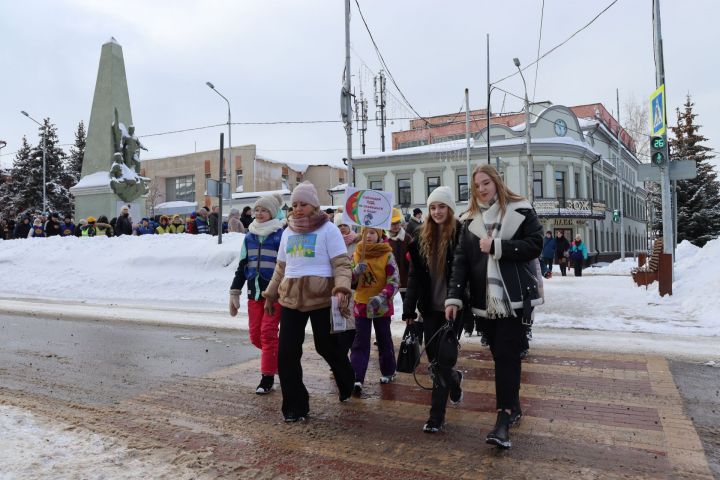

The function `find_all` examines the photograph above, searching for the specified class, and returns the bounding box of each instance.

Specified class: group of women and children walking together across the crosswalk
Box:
[229,165,543,448]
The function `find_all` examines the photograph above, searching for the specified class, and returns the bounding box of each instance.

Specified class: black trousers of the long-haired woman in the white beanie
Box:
[423,312,462,423]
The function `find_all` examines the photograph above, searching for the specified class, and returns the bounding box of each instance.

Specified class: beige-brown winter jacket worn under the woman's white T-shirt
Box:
[262,254,352,312]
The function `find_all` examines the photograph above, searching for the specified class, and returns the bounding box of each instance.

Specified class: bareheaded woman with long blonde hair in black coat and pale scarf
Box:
[445,165,543,448]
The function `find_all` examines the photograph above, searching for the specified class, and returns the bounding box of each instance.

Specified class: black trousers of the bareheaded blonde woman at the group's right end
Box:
[482,312,527,410]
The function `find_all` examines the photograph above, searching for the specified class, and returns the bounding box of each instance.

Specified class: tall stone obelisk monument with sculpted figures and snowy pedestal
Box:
[70,38,147,220]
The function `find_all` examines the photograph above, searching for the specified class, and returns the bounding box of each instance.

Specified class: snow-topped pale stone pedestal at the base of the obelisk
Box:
[70,172,146,223]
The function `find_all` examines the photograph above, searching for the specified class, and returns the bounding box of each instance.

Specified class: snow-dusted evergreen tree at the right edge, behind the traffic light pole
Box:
[669,95,720,247]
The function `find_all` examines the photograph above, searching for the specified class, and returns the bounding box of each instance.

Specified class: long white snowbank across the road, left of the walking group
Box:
[0,233,244,307]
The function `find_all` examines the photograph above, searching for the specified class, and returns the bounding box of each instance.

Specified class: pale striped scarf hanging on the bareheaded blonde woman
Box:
[479,198,512,318]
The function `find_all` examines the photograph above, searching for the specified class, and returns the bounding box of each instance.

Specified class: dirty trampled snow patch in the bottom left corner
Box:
[0,405,195,479]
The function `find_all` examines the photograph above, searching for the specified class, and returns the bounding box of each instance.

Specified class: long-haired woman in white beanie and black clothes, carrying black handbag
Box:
[403,187,462,433]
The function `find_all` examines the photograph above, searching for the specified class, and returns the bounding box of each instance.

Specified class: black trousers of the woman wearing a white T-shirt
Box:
[278,307,355,415]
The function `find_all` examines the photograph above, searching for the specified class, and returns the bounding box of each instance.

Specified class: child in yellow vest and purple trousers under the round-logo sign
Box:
[350,227,400,396]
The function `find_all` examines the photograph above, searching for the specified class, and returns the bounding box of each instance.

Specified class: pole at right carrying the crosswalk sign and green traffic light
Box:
[653,0,675,264]
